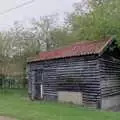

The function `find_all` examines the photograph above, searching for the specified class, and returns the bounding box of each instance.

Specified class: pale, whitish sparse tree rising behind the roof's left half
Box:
[32,15,57,51]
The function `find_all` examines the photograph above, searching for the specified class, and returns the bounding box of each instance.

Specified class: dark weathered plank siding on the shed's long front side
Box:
[28,56,100,107]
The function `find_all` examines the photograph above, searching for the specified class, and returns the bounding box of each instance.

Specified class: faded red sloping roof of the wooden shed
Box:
[28,38,112,62]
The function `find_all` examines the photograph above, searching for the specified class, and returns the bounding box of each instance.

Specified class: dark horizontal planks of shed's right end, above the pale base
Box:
[100,56,120,97]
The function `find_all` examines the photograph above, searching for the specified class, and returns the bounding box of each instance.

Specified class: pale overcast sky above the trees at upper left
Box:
[0,0,80,30]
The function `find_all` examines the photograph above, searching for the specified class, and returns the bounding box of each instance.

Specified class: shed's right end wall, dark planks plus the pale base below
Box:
[100,54,120,110]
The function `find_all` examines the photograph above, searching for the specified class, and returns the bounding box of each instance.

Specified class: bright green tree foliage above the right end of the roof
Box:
[68,0,120,40]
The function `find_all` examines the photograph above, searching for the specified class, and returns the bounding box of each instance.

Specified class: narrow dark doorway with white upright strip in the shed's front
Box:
[34,70,43,99]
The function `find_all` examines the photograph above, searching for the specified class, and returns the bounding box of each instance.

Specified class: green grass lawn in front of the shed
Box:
[0,90,120,120]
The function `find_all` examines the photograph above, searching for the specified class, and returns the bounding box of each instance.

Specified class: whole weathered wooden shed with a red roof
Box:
[27,38,120,109]
